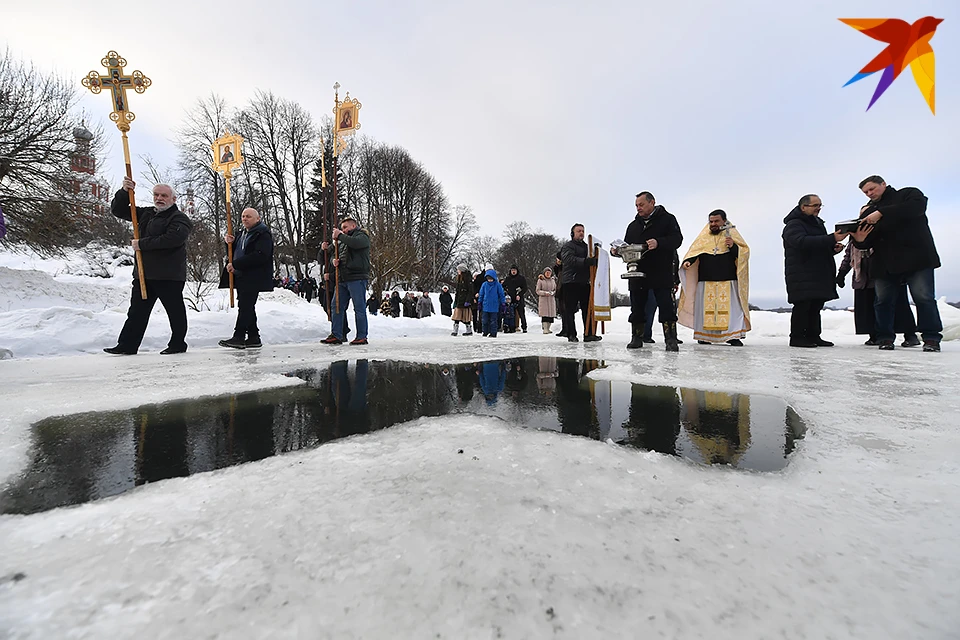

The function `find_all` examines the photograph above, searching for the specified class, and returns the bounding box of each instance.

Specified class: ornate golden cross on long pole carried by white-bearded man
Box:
[81,51,153,300]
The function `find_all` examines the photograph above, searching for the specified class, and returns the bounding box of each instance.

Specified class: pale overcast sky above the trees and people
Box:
[0,0,960,306]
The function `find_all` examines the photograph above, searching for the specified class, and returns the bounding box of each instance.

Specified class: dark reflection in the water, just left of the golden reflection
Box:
[623,384,680,455]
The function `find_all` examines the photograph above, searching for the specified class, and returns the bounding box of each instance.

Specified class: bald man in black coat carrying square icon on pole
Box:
[219,208,274,349]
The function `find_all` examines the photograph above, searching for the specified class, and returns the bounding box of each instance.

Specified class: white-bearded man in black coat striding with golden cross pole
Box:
[104,178,193,355]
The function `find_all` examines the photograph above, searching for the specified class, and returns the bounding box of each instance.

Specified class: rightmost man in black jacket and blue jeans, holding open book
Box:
[853,175,943,352]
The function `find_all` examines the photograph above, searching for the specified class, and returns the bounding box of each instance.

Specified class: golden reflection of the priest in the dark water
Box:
[680,389,750,465]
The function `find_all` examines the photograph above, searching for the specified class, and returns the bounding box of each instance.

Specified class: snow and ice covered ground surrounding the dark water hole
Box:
[0,246,960,639]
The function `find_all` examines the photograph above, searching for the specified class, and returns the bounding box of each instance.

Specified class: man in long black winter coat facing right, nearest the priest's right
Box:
[782,194,849,347]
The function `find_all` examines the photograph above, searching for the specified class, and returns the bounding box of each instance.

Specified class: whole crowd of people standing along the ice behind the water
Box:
[104,175,943,354]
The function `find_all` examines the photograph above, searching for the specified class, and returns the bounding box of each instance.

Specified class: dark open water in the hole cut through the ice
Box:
[0,357,804,513]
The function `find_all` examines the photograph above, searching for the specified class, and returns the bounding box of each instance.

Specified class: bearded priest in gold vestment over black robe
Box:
[677,209,750,347]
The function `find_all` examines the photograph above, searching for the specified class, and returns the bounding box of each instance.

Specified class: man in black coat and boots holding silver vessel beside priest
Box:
[614,191,683,351]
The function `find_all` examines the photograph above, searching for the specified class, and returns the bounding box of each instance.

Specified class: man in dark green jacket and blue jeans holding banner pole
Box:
[321,216,370,344]
